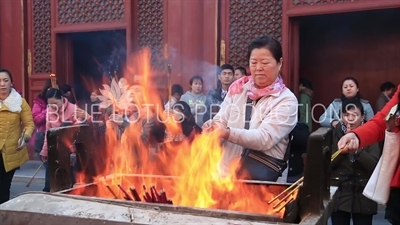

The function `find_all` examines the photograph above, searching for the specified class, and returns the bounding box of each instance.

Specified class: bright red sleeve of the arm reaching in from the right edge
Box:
[353,85,400,148]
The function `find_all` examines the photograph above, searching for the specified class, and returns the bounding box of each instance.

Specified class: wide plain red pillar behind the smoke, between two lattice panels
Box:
[164,0,218,91]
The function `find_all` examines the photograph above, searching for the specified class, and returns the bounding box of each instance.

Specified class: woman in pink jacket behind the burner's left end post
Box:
[40,88,90,191]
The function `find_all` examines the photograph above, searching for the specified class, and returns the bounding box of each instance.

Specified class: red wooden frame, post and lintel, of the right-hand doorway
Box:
[282,0,400,93]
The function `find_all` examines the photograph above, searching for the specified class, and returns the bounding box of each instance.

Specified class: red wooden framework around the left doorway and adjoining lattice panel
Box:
[25,0,138,103]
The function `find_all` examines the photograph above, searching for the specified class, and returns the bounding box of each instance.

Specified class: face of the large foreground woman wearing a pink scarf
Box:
[249,48,282,88]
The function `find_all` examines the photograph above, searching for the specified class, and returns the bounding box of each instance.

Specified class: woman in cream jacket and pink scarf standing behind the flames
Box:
[203,36,298,181]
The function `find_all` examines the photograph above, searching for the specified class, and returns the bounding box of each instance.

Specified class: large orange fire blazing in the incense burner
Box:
[69,50,296,217]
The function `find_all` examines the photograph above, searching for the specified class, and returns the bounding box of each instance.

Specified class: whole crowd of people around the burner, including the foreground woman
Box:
[0,36,400,225]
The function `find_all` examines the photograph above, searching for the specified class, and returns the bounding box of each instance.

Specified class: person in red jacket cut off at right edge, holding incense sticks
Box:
[338,85,400,224]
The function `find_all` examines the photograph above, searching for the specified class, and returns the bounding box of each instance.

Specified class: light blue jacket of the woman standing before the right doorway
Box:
[319,98,374,127]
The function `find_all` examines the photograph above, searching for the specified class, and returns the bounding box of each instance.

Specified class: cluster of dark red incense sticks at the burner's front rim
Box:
[106,184,172,205]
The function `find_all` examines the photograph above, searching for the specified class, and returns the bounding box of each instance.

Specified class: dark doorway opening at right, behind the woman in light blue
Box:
[299,8,400,128]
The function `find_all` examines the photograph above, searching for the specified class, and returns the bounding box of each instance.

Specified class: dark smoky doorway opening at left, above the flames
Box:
[68,30,126,102]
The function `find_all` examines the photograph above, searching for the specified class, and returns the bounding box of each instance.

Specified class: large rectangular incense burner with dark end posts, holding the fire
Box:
[0,125,336,224]
